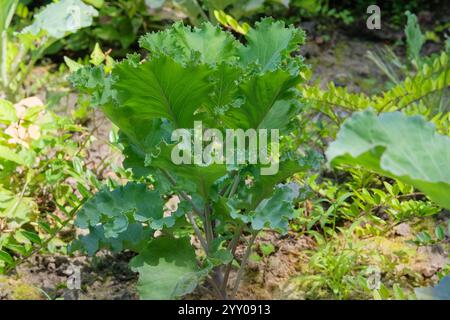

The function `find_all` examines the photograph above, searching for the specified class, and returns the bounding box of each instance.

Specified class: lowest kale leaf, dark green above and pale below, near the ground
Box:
[130,236,200,300]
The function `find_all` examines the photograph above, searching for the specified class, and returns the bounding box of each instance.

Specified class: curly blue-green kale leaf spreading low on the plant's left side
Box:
[70,183,192,255]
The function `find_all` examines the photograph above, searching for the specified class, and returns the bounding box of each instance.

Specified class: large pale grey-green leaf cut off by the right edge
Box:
[327,110,450,209]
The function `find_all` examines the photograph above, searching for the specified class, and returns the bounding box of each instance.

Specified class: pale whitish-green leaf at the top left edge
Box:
[22,0,98,39]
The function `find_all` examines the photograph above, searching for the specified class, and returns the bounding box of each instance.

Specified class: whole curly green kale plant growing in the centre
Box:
[71,19,320,299]
